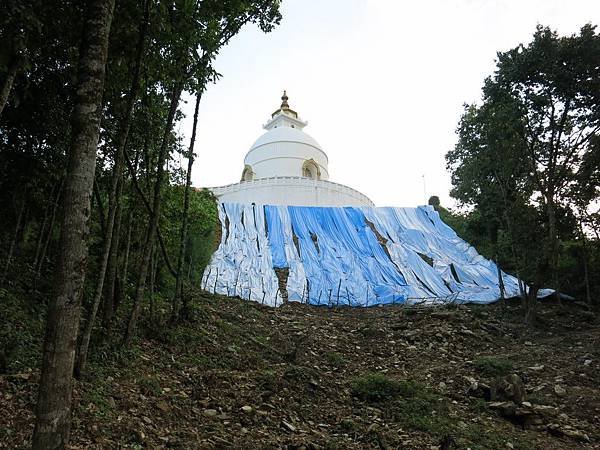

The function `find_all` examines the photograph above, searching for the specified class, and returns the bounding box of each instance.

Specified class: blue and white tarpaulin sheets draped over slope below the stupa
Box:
[203,203,519,306]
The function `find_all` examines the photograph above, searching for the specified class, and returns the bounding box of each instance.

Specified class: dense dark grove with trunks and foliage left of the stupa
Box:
[0,0,280,448]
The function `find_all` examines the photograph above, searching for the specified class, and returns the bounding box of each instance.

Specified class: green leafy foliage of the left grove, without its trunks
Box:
[0,0,281,362]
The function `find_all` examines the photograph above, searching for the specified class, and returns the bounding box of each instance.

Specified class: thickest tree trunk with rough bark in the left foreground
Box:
[33,0,115,450]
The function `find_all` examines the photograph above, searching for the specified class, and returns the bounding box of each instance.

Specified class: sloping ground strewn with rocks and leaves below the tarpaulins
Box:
[0,295,600,450]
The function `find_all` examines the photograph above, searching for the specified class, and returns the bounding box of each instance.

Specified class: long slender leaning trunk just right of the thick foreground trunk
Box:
[75,0,149,378]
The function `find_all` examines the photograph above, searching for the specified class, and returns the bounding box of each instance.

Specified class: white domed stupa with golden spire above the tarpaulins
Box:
[210,91,374,206]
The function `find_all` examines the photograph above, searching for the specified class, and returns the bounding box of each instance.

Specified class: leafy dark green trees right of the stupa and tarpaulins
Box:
[433,25,600,320]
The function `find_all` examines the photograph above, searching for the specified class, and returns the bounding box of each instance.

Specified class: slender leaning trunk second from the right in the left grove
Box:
[124,82,183,345]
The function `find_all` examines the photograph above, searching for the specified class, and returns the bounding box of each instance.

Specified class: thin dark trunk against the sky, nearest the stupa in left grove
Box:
[171,91,202,322]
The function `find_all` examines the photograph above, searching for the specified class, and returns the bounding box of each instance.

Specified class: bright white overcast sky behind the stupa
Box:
[180,0,600,206]
